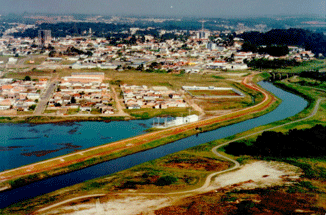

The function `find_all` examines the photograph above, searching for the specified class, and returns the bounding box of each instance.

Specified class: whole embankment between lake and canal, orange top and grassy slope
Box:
[0,73,276,191]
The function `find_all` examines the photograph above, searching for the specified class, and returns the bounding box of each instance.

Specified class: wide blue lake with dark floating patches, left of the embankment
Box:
[0,119,153,171]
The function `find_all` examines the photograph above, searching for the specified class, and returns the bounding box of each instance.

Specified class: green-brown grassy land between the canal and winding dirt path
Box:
[0,144,232,214]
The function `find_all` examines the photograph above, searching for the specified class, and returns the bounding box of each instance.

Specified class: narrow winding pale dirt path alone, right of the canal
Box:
[34,97,326,214]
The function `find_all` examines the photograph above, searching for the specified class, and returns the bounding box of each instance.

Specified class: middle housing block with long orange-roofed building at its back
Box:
[47,72,114,114]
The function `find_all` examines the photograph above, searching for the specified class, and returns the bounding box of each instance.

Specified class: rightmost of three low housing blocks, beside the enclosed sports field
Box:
[120,84,188,109]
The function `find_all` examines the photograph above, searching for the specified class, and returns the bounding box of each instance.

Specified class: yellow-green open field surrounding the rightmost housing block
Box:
[0,69,255,120]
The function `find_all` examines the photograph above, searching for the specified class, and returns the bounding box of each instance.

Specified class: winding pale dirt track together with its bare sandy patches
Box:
[35,96,325,214]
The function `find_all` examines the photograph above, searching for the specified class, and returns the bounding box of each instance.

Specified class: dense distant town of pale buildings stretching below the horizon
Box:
[0,24,314,73]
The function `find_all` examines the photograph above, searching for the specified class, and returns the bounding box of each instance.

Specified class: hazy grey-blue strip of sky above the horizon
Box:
[0,0,326,17]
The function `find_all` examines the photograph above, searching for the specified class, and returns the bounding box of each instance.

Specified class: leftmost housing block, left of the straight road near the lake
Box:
[0,79,48,111]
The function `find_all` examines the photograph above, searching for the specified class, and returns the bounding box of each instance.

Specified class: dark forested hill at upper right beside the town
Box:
[238,28,326,55]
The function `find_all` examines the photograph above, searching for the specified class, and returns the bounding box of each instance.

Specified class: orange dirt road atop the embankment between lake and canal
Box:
[0,75,274,185]
